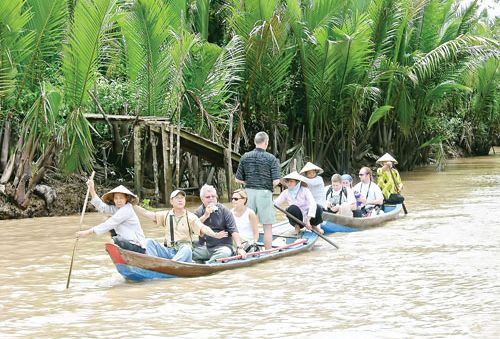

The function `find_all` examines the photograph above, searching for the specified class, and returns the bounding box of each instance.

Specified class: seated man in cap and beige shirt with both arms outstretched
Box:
[134,190,227,262]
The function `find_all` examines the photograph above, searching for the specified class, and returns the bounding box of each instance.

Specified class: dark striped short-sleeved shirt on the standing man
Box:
[236,148,280,192]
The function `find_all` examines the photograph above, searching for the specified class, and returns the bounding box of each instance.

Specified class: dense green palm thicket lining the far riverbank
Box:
[0,0,500,209]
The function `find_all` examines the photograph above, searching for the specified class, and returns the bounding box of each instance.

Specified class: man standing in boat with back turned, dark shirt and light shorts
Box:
[236,132,280,249]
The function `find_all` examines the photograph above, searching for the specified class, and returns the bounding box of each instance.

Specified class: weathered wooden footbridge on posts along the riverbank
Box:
[85,114,240,204]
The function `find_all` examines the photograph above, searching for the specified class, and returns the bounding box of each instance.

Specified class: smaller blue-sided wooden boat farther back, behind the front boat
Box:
[321,204,403,234]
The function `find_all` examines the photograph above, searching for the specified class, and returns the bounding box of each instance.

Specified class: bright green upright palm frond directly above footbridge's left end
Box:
[62,0,116,111]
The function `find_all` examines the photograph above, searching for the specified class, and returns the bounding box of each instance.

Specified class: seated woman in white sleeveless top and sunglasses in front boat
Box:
[231,189,259,248]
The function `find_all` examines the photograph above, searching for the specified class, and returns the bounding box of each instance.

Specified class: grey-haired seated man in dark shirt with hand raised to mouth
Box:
[193,184,246,264]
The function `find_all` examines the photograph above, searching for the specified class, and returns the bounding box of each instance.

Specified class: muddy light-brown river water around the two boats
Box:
[0,156,500,338]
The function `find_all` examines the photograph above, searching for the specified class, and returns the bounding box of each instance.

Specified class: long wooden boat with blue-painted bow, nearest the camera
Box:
[106,224,318,281]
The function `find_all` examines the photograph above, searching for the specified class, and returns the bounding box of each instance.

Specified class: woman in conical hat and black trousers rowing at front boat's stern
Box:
[274,171,324,234]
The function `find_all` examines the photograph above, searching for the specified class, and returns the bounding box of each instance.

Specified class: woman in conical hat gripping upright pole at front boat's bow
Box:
[76,179,146,253]
